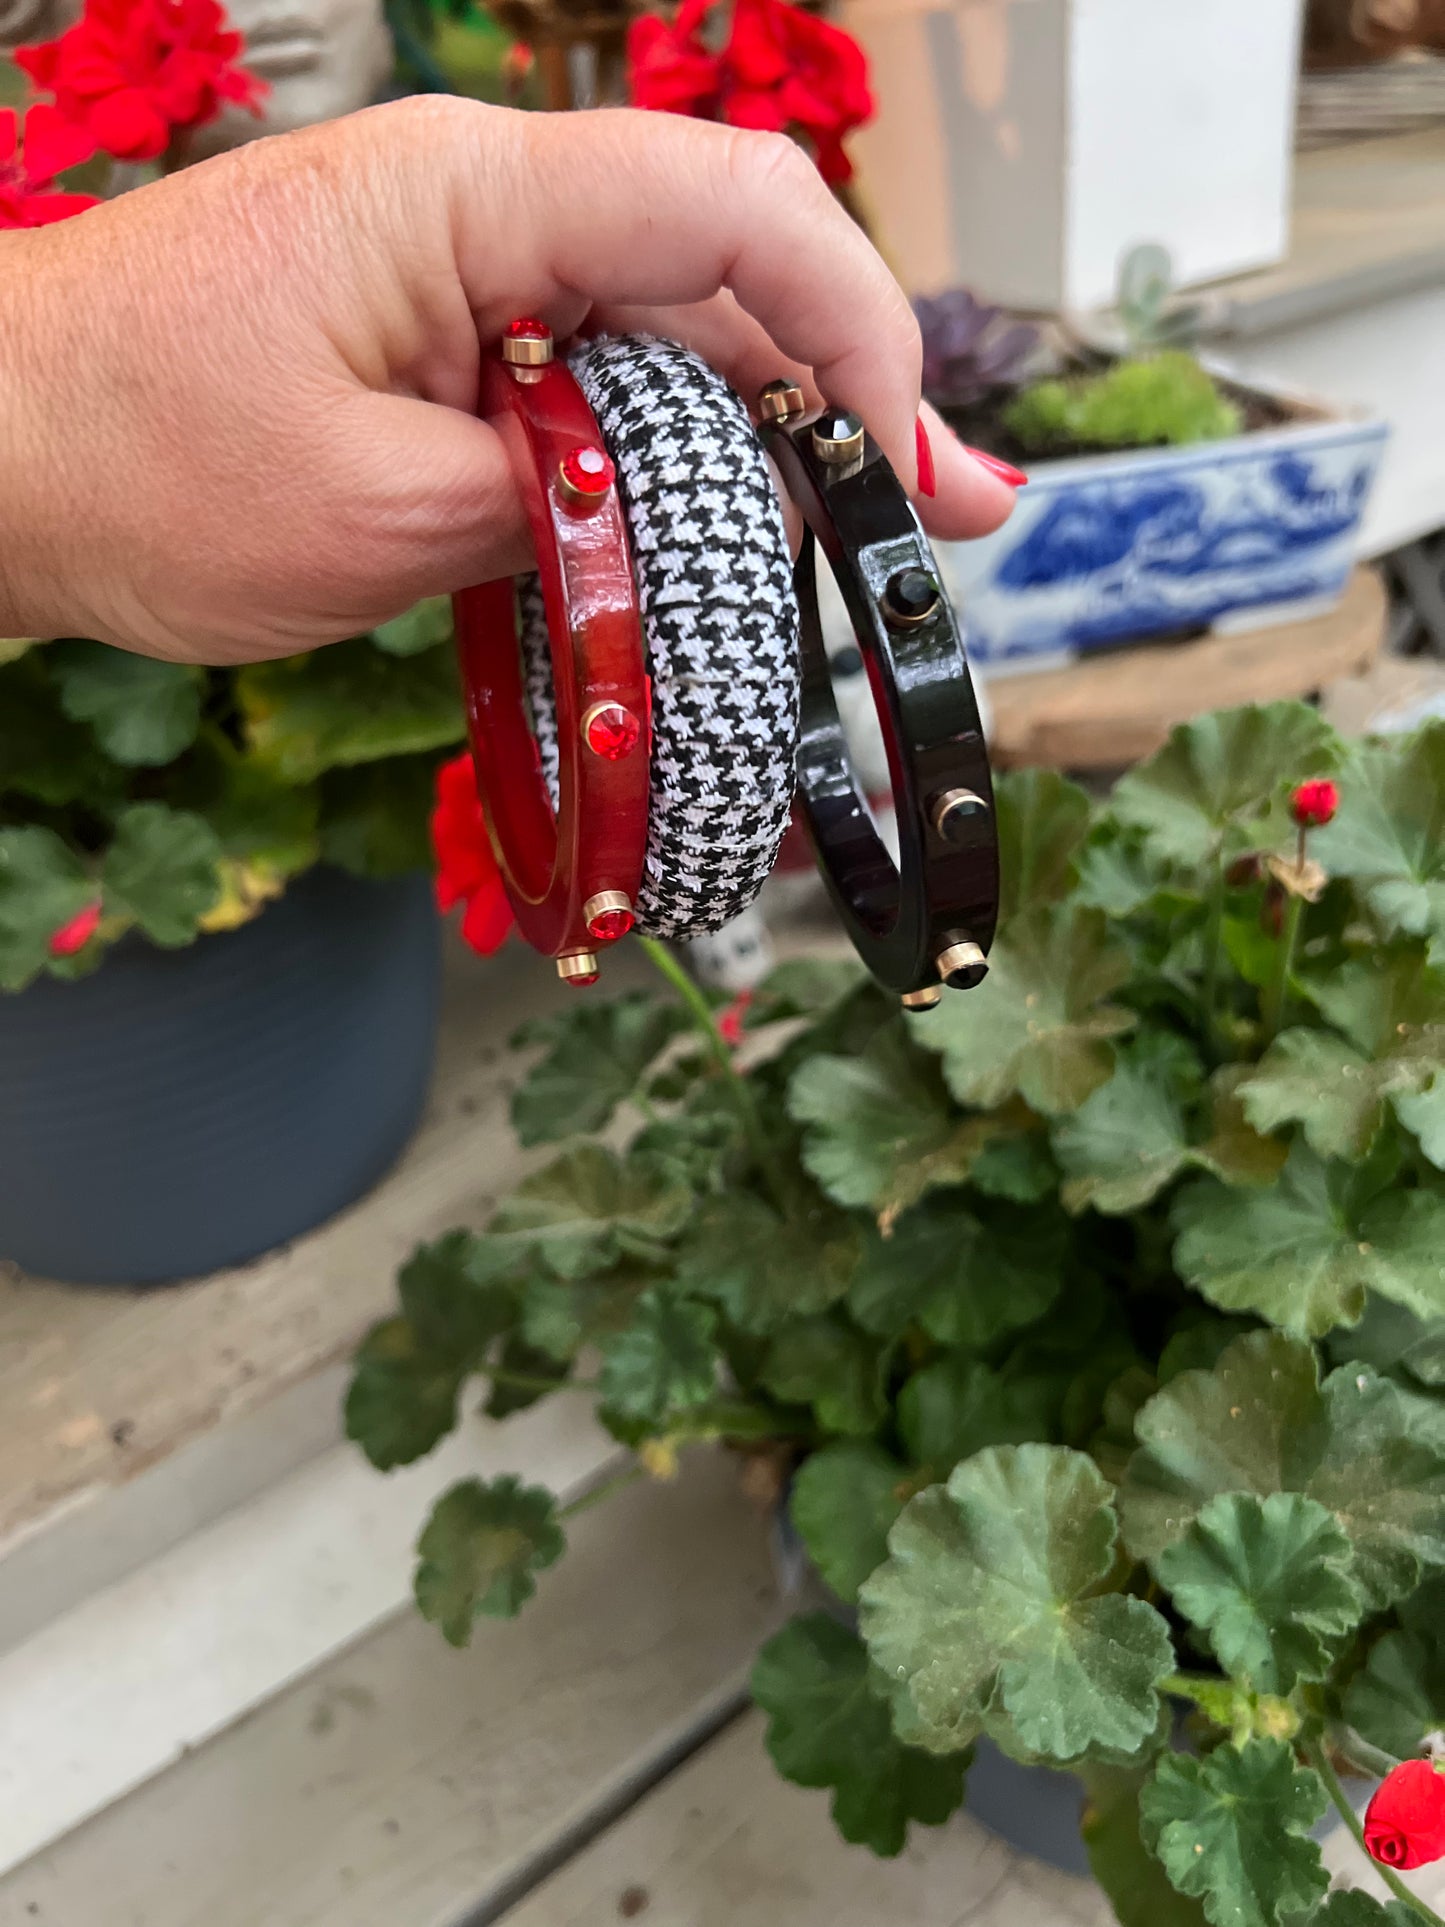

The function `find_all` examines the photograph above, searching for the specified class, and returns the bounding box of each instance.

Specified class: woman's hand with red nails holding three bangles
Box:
[0,96,1012,663]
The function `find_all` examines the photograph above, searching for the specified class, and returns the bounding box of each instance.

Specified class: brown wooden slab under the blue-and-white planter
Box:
[988,568,1385,769]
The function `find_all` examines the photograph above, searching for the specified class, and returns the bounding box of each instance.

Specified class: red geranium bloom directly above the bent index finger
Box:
[628,0,873,185]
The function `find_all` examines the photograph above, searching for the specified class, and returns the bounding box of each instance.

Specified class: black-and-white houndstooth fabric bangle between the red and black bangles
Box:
[522,335,800,938]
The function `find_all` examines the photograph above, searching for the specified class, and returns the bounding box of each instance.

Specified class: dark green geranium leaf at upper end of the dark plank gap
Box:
[753,1613,967,1858]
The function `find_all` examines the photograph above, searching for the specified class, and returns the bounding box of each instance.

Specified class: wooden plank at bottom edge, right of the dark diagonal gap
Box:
[504,1713,1114,1927]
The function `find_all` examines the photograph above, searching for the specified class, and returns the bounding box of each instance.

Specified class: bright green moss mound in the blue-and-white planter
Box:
[1004,351,1243,453]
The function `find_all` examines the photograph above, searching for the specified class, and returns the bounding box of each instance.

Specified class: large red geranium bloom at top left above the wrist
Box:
[15,0,266,160]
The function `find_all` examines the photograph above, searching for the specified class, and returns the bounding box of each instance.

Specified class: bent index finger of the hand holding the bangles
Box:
[455,108,923,486]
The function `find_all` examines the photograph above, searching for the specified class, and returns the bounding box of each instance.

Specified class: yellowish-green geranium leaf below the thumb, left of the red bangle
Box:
[235,636,464,782]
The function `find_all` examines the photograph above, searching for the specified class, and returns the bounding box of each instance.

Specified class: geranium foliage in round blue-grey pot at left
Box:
[0,603,462,1283]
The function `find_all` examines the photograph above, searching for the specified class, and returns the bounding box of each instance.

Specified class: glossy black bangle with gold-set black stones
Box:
[759,382,998,1008]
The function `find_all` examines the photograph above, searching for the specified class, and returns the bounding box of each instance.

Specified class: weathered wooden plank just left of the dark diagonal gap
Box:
[0,1453,786,1927]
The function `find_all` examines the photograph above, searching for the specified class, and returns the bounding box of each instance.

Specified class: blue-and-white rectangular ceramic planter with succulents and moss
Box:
[919,262,1387,667]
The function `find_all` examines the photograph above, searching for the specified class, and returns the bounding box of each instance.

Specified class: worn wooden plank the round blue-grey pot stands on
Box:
[0,944,645,1557]
